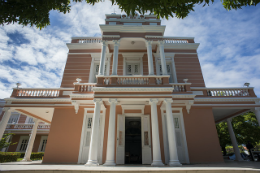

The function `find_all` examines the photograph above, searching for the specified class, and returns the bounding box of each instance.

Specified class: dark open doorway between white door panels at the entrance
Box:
[125,117,142,164]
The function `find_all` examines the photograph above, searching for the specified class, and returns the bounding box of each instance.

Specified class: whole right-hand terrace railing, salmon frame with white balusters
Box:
[191,87,256,97]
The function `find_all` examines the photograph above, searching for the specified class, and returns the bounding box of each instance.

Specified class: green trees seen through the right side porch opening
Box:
[216,112,260,155]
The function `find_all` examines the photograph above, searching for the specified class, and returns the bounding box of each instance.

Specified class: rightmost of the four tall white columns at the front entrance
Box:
[164,99,181,166]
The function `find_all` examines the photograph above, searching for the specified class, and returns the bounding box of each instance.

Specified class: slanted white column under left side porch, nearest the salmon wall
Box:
[22,119,39,161]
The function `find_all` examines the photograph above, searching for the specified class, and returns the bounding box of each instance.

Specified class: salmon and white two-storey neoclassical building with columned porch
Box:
[0,14,260,166]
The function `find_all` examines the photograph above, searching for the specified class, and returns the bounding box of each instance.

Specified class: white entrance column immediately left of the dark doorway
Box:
[104,99,117,166]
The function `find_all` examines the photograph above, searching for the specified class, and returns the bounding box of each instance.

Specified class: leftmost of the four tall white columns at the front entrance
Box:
[85,99,102,166]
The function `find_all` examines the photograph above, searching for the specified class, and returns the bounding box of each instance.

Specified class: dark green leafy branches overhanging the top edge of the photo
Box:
[0,0,260,29]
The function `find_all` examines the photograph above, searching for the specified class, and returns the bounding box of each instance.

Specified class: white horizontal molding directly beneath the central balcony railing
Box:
[93,87,173,92]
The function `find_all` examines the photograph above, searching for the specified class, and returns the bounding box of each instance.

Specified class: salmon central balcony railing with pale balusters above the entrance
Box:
[97,75,170,87]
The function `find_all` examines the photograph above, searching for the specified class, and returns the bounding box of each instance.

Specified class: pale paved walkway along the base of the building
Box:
[0,161,260,173]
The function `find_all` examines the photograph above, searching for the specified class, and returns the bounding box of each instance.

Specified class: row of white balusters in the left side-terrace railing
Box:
[17,89,60,97]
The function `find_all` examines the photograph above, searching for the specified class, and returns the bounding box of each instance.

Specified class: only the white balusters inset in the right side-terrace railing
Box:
[207,88,249,97]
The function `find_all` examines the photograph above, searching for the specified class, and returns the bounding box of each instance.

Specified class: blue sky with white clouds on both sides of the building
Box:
[0,1,260,98]
